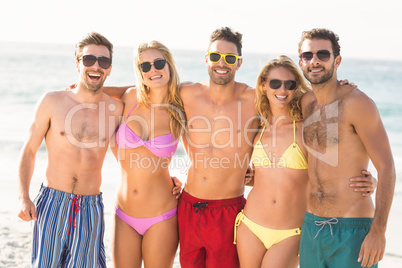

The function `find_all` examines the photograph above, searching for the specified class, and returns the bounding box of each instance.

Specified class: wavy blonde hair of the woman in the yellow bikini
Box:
[255,55,310,125]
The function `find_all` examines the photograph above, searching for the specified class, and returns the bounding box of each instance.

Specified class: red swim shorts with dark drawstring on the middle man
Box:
[177,191,246,268]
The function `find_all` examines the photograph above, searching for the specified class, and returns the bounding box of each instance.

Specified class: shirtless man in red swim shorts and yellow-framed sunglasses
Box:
[178,27,258,268]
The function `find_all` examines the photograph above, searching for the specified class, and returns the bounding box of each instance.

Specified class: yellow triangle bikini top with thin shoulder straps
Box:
[251,120,308,169]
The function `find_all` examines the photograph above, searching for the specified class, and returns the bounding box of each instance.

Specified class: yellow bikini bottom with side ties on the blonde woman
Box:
[233,210,301,249]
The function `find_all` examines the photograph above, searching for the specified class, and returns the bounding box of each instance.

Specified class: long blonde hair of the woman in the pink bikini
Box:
[134,40,187,138]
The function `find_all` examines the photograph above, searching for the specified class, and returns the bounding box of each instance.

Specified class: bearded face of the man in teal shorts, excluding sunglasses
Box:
[299,39,341,85]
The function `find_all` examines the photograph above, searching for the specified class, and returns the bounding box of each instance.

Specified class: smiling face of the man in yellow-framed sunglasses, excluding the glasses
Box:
[205,40,242,85]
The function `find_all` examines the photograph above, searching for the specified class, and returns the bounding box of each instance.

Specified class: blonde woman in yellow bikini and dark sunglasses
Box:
[235,56,371,267]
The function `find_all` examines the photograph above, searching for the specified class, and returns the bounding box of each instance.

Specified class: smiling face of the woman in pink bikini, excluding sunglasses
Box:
[137,49,170,88]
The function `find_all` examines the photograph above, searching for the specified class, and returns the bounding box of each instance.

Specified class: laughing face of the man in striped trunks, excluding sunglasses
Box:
[77,45,112,94]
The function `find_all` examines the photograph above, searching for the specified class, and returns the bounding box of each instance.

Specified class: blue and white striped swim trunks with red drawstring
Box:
[31,185,106,267]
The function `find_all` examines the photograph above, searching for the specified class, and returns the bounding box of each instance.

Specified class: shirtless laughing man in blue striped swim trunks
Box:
[18,33,123,267]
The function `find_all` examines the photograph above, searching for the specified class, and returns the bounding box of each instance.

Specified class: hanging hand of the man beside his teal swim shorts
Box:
[357,230,385,267]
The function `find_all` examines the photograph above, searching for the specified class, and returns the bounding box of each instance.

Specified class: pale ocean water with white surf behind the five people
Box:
[0,43,402,195]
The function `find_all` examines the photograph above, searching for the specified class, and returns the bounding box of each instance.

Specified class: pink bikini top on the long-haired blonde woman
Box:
[116,102,178,157]
